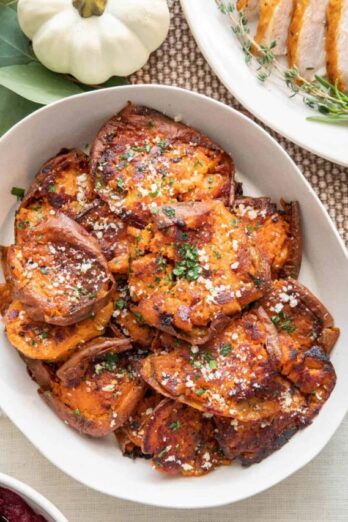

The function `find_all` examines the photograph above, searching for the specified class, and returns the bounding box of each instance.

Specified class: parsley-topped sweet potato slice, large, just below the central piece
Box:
[141,304,290,421]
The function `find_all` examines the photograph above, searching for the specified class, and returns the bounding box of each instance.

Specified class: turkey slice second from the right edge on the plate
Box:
[288,0,329,80]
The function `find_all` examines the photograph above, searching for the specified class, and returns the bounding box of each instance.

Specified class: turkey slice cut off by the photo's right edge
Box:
[326,0,348,91]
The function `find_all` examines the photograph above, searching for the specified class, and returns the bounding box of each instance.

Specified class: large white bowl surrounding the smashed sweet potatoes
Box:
[0,85,348,508]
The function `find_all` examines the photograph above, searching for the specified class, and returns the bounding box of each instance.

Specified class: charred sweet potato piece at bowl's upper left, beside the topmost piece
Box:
[15,149,95,242]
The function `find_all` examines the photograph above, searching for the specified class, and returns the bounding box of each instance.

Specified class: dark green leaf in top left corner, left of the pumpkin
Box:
[0,0,36,67]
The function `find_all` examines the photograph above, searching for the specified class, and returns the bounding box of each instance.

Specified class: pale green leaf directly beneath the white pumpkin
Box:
[0,62,83,105]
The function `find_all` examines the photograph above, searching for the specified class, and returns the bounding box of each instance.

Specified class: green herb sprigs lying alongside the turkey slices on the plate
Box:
[215,0,348,125]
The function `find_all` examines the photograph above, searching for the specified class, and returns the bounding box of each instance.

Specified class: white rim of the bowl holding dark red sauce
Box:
[0,473,68,522]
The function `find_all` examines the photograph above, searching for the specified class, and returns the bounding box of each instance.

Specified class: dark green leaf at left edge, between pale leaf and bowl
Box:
[0,86,41,135]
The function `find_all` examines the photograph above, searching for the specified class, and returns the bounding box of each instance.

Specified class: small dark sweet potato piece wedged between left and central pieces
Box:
[78,200,128,274]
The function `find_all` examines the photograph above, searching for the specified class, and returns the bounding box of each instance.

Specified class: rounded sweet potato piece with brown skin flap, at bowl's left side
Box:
[7,214,115,326]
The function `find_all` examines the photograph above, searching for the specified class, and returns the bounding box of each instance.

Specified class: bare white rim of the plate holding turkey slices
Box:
[181,0,348,166]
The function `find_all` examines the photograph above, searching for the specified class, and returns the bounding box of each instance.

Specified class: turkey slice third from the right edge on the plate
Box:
[255,0,294,55]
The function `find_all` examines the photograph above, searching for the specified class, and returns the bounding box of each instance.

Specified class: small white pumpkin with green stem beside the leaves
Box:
[18,0,169,85]
